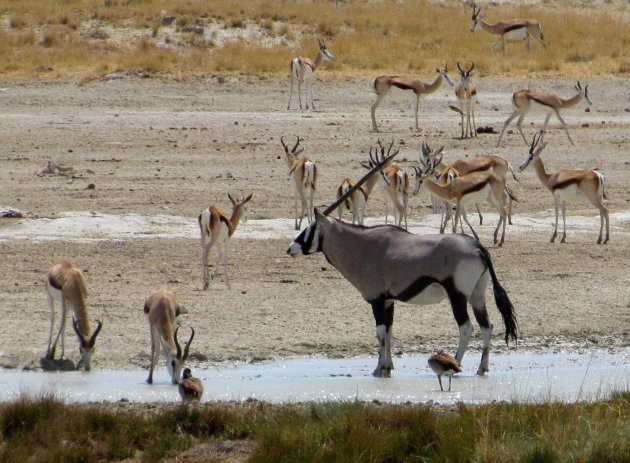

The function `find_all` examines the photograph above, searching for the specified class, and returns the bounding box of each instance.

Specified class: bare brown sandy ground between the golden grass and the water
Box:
[0,74,630,374]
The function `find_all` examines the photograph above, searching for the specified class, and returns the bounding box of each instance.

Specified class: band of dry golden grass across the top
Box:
[0,0,630,78]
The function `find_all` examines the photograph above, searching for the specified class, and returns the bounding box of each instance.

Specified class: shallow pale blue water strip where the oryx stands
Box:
[0,349,630,403]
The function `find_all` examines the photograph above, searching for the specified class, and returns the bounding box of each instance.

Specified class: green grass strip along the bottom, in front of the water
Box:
[0,393,630,462]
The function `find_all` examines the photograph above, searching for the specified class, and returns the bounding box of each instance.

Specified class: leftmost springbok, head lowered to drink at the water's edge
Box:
[46,260,103,371]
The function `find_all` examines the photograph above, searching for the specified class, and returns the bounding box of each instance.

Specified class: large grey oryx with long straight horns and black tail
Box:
[287,150,518,377]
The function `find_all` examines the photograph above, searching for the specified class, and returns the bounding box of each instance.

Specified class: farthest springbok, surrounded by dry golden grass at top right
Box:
[470,6,547,53]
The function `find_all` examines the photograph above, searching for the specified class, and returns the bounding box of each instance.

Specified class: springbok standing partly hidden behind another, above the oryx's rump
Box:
[422,140,519,225]
